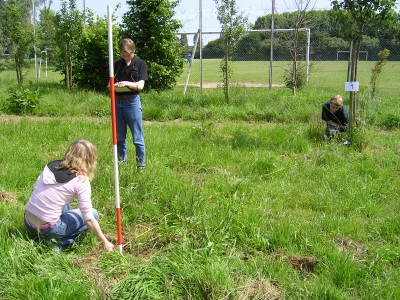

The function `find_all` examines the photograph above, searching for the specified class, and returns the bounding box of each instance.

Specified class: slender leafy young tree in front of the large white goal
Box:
[214,0,248,102]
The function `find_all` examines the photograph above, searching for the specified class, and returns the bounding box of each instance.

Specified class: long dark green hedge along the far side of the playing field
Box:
[250,9,400,60]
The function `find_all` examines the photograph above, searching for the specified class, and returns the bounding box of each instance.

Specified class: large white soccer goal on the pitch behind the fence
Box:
[176,28,310,94]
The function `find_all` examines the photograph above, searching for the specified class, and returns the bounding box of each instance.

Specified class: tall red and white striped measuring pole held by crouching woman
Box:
[107,5,122,253]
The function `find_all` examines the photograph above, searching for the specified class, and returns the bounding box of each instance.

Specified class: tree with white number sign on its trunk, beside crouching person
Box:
[331,0,396,128]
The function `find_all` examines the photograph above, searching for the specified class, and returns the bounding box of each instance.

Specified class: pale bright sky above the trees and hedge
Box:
[52,0,331,32]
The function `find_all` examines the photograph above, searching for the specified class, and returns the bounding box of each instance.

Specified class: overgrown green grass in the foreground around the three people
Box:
[0,67,400,300]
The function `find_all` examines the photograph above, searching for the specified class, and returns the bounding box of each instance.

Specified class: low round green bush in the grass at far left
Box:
[6,86,41,115]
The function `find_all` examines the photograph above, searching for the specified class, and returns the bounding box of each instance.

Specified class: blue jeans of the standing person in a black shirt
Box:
[115,95,146,167]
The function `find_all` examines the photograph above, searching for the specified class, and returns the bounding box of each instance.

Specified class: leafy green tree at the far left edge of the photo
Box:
[1,0,34,85]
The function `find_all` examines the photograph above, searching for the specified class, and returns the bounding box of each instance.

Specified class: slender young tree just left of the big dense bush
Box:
[55,0,84,89]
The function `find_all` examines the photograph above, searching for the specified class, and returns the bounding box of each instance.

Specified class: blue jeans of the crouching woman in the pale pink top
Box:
[25,204,99,246]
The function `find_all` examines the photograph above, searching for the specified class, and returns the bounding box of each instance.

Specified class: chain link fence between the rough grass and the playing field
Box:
[178,30,400,95]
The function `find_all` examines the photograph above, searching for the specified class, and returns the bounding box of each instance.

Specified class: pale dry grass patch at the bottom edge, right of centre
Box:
[237,279,284,300]
